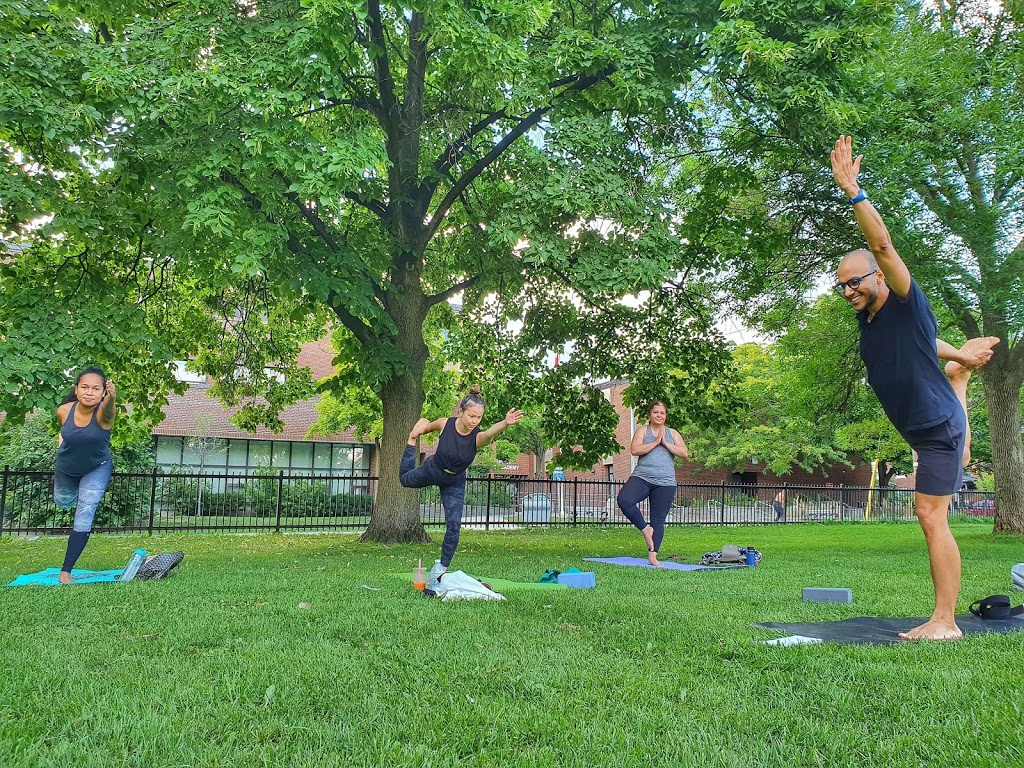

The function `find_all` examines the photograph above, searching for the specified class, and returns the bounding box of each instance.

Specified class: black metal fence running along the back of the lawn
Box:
[0,468,995,535]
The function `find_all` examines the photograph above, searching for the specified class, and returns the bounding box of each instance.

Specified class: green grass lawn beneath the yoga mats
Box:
[0,523,1024,768]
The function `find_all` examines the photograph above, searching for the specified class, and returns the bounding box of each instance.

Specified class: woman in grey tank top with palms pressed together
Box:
[618,402,689,566]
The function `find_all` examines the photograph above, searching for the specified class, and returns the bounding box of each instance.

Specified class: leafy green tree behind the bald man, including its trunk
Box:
[714,0,1024,532]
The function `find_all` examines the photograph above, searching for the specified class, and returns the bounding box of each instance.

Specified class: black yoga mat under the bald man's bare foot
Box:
[755,614,1024,645]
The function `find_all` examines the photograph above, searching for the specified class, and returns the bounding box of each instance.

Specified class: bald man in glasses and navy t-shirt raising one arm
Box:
[831,136,999,640]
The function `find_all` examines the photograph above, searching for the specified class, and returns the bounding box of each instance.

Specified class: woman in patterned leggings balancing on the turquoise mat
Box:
[53,368,116,584]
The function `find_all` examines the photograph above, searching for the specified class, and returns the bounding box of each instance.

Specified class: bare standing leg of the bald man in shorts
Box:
[899,494,964,640]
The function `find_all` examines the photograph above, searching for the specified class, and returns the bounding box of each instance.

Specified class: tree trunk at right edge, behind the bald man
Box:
[983,355,1024,534]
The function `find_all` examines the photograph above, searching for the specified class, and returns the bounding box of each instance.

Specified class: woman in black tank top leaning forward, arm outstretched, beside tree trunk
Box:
[398,386,522,590]
